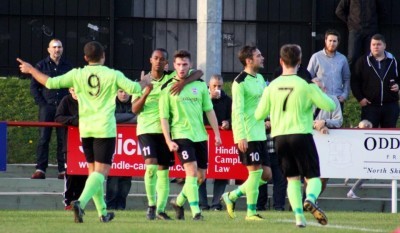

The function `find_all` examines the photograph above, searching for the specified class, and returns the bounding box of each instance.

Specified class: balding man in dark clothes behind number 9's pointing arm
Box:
[30,39,72,179]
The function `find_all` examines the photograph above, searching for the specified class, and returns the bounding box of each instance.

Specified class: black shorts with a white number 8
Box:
[174,139,208,169]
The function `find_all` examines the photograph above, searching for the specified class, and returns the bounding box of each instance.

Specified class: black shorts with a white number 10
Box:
[236,141,270,167]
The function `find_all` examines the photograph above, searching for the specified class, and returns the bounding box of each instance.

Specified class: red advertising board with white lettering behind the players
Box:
[67,125,248,180]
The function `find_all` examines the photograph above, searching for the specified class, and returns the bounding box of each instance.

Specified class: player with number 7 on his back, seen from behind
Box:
[255,44,336,227]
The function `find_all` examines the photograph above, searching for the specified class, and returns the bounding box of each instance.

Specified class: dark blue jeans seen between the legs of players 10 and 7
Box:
[257,153,287,210]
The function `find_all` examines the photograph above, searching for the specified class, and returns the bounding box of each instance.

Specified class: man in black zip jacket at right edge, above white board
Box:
[350,34,400,128]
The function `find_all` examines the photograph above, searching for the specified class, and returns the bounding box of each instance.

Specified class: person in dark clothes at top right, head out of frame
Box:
[336,0,387,69]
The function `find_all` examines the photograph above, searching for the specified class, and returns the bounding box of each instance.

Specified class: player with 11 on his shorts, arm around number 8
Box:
[132,48,203,220]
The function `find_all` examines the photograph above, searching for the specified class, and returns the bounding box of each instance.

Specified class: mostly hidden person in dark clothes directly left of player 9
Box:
[55,88,87,210]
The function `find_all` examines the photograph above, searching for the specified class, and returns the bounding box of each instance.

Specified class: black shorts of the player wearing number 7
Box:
[274,134,321,178]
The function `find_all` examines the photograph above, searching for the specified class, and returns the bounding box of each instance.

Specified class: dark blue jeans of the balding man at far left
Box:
[36,104,65,172]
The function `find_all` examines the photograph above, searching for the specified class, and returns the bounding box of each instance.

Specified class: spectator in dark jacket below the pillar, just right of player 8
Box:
[199,74,232,210]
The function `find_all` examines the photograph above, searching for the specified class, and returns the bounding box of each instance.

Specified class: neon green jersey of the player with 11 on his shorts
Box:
[132,71,176,135]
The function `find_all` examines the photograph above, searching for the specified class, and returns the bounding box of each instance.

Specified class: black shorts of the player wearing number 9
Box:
[82,137,115,165]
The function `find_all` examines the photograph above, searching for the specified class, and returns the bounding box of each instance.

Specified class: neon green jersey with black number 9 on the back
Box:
[46,65,141,138]
